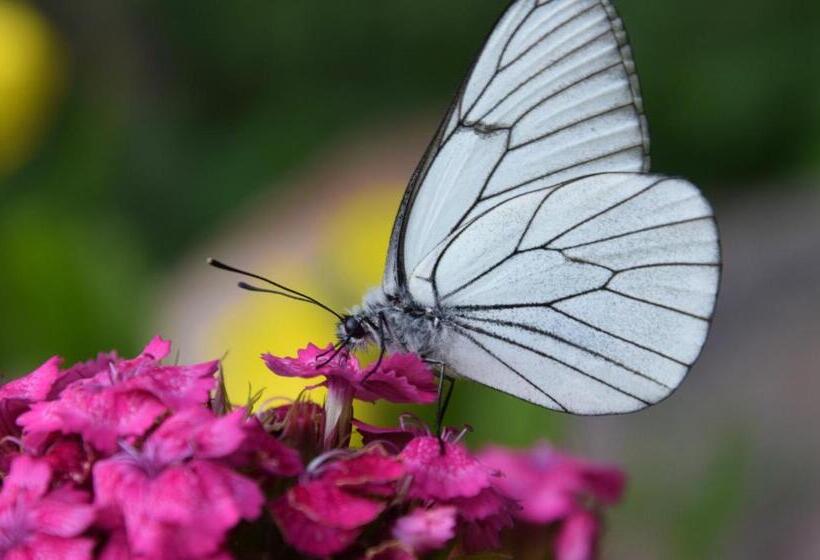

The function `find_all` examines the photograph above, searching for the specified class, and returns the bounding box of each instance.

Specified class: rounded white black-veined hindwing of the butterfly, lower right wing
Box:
[409,173,720,414]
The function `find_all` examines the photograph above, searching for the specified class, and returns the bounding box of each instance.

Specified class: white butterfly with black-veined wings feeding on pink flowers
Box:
[215,0,720,414]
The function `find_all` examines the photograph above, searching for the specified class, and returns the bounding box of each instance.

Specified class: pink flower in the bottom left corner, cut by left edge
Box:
[0,456,94,560]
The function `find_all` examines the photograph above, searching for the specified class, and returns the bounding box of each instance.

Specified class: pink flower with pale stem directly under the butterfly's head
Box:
[262,344,438,449]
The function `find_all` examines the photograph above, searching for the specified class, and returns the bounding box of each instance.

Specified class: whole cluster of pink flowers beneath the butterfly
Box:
[0,337,624,560]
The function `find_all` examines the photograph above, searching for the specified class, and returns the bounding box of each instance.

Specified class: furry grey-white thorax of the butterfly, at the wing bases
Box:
[351,287,446,360]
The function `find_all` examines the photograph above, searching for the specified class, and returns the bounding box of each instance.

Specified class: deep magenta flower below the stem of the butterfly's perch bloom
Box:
[270,447,404,556]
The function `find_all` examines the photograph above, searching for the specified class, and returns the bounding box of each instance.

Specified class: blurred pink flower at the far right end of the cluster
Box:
[479,444,625,523]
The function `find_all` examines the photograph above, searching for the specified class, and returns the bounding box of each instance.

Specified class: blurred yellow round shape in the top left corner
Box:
[0,0,63,176]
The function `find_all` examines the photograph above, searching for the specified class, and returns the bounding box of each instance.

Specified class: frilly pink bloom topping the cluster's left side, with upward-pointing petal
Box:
[18,337,217,453]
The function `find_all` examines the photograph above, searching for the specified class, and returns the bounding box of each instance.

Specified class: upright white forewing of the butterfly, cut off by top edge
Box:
[385,0,649,288]
